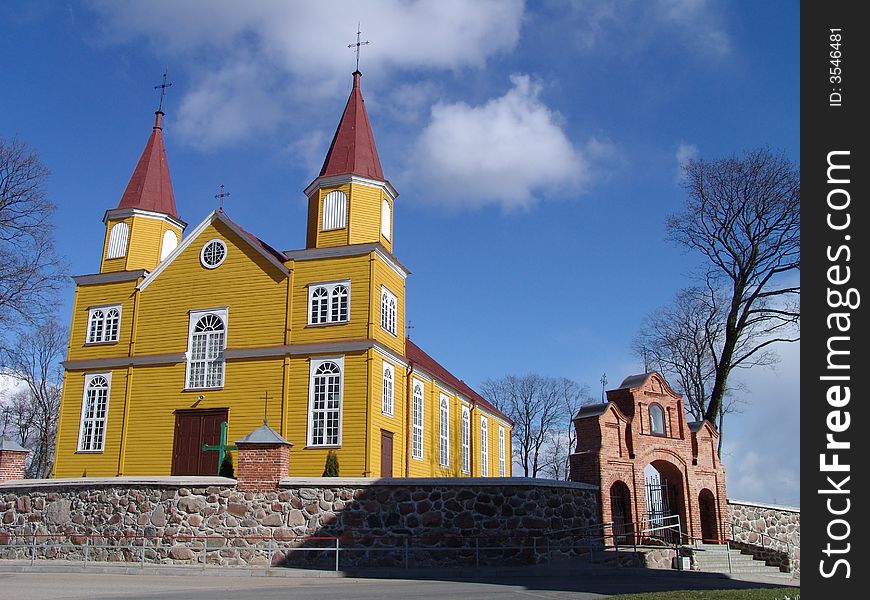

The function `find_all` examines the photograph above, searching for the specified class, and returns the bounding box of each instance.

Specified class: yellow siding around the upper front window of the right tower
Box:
[291,255,369,344]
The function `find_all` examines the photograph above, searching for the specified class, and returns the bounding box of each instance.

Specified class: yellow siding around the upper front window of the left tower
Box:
[67,280,138,360]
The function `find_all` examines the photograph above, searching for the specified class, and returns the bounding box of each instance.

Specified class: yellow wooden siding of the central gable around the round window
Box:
[135,221,287,355]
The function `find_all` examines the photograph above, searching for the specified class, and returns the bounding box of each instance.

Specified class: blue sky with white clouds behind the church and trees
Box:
[0,0,800,504]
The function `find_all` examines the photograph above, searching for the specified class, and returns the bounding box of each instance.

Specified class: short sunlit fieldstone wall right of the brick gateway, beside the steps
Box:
[728,499,801,578]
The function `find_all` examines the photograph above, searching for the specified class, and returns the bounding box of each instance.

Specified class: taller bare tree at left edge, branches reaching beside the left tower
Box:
[0,138,64,345]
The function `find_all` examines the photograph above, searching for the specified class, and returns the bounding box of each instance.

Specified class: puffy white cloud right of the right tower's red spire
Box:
[404,74,599,210]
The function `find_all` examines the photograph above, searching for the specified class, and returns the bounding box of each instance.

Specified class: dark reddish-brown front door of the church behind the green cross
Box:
[172,408,227,475]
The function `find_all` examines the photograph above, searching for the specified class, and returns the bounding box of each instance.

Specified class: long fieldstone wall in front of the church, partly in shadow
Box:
[0,477,599,568]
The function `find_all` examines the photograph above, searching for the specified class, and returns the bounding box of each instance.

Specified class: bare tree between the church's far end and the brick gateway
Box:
[482,374,585,478]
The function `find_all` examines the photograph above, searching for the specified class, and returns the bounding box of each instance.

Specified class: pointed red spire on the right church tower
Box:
[320,71,384,181]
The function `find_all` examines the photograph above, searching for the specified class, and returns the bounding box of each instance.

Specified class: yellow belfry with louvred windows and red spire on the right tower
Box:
[305,71,398,253]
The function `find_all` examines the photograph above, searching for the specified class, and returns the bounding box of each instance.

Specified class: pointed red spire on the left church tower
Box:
[118,110,178,219]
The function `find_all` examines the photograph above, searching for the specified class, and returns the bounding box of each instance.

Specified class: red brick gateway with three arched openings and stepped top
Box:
[570,373,731,541]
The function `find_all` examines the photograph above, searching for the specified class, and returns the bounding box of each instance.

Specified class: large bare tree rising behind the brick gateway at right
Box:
[667,149,800,423]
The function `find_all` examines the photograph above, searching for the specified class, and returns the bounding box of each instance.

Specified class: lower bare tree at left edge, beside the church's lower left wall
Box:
[2,320,67,478]
